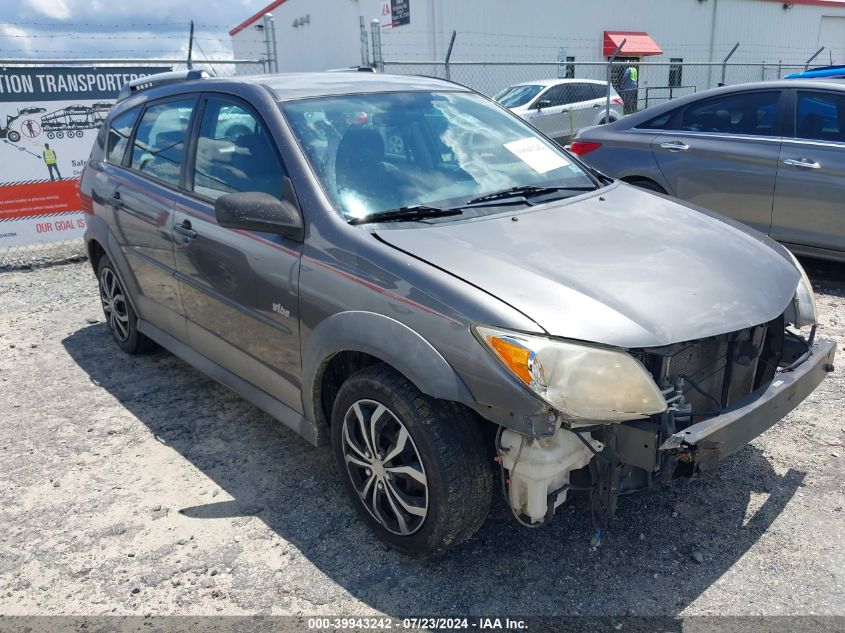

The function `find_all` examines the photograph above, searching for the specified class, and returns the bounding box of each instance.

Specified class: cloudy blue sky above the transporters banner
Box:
[0,0,270,60]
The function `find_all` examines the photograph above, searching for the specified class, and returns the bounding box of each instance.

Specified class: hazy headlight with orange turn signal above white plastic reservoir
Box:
[473,326,666,422]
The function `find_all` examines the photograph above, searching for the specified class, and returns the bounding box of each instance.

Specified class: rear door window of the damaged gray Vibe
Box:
[131,99,196,186]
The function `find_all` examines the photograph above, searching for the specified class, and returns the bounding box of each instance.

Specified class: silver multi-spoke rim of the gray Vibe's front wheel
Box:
[342,400,428,536]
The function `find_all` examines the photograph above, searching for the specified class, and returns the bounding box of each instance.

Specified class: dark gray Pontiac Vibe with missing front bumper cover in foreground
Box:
[81,71,834,556]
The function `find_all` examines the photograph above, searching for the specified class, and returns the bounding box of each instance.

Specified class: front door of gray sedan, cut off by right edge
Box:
[771,90,845,252]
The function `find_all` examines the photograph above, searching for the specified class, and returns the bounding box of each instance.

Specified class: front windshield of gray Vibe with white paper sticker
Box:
[281,92,595,219]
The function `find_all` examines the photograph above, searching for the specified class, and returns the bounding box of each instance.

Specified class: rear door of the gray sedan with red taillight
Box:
[651,90,785,233]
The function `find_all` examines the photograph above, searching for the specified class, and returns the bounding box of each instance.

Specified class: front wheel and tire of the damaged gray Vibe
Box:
[331,365,493,557]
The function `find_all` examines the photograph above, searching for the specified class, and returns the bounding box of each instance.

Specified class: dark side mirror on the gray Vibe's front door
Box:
[214,182,304,242]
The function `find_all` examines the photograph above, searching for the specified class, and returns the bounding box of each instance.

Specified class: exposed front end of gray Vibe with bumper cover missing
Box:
[496,316,833,527]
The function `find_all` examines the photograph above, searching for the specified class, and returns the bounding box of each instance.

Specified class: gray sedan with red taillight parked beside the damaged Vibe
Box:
[572,79,845,261]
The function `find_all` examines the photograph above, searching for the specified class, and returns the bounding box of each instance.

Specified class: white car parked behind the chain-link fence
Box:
[493,79,624,141]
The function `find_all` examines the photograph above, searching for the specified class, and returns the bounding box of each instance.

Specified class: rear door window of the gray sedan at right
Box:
[680,92,780,136]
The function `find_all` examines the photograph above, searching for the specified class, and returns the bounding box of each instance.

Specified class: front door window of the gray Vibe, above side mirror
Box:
[194,99,284,200]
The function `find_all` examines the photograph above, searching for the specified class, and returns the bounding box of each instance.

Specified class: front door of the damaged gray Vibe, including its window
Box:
[173,94,302,411]
